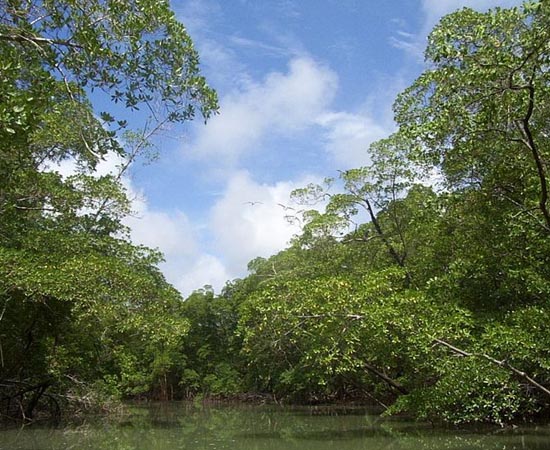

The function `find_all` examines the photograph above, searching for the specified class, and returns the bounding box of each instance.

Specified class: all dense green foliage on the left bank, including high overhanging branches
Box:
[0,0,217,419]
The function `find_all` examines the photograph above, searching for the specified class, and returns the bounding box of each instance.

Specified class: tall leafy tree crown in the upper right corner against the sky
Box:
[395,2,550,233]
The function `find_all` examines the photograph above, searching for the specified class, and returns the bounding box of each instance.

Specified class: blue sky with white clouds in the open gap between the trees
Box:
[103,0,519,296]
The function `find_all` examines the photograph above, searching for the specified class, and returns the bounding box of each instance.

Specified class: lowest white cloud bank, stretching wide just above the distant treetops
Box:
[157,171,328,296]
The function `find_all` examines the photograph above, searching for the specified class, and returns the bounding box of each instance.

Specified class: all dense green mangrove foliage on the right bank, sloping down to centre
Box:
[178,2,550,423]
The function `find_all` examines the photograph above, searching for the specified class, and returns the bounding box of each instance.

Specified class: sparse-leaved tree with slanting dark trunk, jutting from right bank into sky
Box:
[292,134,430,283]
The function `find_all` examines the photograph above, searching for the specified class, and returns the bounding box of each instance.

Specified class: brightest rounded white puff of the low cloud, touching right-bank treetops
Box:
[210,171,316,276]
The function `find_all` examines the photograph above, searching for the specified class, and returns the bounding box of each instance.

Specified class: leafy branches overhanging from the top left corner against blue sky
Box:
[0,0,217,121]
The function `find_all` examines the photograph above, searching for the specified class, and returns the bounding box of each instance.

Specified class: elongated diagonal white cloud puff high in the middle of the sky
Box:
[188,57,338,163]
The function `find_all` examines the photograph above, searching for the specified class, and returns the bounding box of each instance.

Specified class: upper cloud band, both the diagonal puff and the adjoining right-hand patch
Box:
[192,52,393,169]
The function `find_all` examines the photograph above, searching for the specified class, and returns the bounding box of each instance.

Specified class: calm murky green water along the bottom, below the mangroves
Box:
[0,403,550,450]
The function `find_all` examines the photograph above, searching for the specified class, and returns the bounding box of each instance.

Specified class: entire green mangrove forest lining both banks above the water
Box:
[0,0,550,425]
